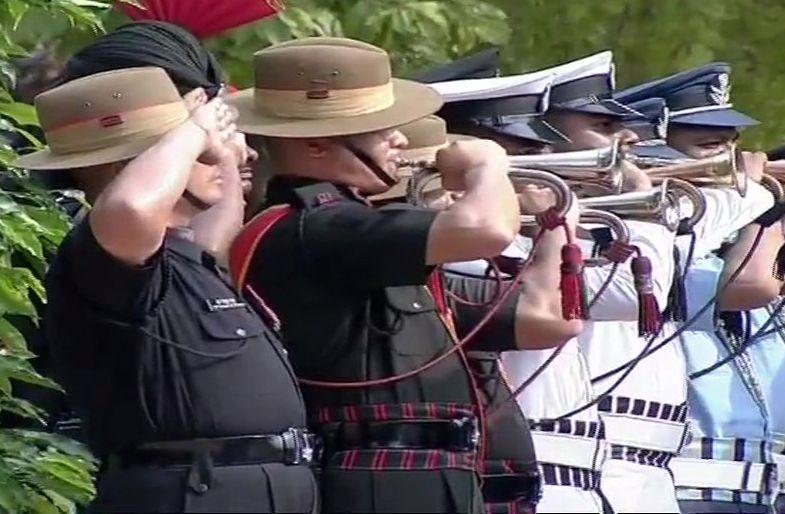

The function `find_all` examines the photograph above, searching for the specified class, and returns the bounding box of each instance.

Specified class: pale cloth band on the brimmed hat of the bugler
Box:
[254,82,395,120]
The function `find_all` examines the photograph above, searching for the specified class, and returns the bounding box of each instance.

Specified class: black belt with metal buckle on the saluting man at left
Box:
[108,428,316,468]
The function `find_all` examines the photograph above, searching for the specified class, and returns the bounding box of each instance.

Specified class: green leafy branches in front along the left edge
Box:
[0,0,105,513]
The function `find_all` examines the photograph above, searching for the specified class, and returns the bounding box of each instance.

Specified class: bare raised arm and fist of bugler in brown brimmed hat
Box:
[426,141,520,265]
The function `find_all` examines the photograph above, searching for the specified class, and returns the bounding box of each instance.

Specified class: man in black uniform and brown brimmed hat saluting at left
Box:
[18,68,316,512]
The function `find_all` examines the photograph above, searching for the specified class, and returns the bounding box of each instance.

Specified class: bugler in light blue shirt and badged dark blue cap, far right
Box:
[617,59,781,512]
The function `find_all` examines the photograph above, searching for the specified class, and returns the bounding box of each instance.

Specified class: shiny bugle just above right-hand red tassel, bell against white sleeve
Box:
[578,178,706,231]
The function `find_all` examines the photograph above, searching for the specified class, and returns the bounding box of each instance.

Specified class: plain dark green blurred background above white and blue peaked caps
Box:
[489,0,785,149]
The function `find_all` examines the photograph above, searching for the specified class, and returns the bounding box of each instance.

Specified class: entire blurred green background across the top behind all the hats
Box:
[10,0,785,149]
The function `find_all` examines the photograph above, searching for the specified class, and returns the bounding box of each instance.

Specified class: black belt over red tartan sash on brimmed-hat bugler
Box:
[321,418,480,452]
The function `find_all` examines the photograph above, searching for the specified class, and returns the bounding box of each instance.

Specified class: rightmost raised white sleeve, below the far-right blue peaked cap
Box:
[677,181,774,259]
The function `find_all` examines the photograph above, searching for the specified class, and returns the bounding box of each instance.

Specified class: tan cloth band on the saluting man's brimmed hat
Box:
[46,101,188,154]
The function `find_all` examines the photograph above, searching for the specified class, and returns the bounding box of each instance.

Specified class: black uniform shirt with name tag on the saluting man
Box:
[45,219,305,454]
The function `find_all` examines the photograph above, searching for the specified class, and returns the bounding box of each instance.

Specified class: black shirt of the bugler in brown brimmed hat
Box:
[248,177,472,416]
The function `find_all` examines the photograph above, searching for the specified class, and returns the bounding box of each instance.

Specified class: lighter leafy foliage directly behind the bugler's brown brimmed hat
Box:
[205,0,511,87]
